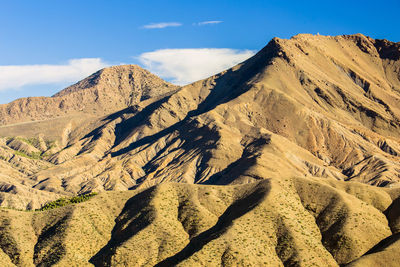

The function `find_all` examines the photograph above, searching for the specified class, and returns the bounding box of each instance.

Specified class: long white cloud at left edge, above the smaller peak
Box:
[0,58,107,91]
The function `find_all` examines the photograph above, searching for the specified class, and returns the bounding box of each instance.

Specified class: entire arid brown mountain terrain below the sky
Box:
[0,34,400,267]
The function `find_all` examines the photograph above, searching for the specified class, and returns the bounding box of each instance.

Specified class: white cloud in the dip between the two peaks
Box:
[139,48,255,85]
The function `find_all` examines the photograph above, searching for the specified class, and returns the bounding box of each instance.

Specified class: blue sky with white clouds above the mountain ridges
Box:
[0,0,400,103]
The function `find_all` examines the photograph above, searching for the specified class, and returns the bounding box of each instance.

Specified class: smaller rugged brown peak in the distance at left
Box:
[0,65,177,125]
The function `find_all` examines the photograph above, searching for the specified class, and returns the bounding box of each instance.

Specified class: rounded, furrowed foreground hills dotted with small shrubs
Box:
[0,178,397,266]
